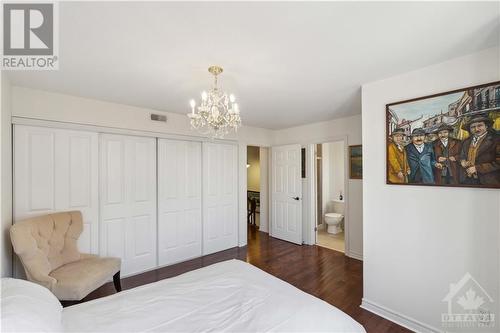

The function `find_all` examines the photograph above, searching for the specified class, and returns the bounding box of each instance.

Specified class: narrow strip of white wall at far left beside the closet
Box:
[0,73,12,276]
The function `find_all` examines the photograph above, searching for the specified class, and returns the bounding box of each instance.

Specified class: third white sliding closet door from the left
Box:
[158,139,202,265]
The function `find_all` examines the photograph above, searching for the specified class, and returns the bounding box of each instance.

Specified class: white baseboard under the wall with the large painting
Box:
[361,298,443,333]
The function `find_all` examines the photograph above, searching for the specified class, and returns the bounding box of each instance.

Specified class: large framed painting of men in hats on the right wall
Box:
[386,82,500,188]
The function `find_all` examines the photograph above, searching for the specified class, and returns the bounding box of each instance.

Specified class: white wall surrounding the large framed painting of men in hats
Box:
[362,48,500,331]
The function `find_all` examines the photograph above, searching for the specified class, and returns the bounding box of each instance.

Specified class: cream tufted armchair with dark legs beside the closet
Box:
[10,211,121,301]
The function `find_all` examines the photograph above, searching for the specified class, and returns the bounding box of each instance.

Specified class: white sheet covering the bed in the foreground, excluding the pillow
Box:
[62,260,365,332]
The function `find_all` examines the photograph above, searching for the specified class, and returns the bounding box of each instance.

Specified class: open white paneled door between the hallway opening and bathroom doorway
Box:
[271,145,302,244]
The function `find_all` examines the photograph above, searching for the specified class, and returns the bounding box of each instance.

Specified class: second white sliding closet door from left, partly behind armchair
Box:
[99,134,157,275]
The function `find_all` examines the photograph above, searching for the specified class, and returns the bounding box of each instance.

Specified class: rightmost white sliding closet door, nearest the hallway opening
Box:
[203,143,238,254]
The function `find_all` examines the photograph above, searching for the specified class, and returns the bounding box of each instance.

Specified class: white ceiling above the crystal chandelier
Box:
[4,2,500,129]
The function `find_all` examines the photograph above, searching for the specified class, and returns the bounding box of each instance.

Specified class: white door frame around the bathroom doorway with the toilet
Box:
[306,135,350,257]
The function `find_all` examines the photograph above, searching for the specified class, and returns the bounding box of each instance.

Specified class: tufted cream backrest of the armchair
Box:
[10,211,83,278]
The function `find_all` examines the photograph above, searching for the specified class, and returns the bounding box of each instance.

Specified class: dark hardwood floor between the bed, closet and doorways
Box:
[71,227,411,333]
